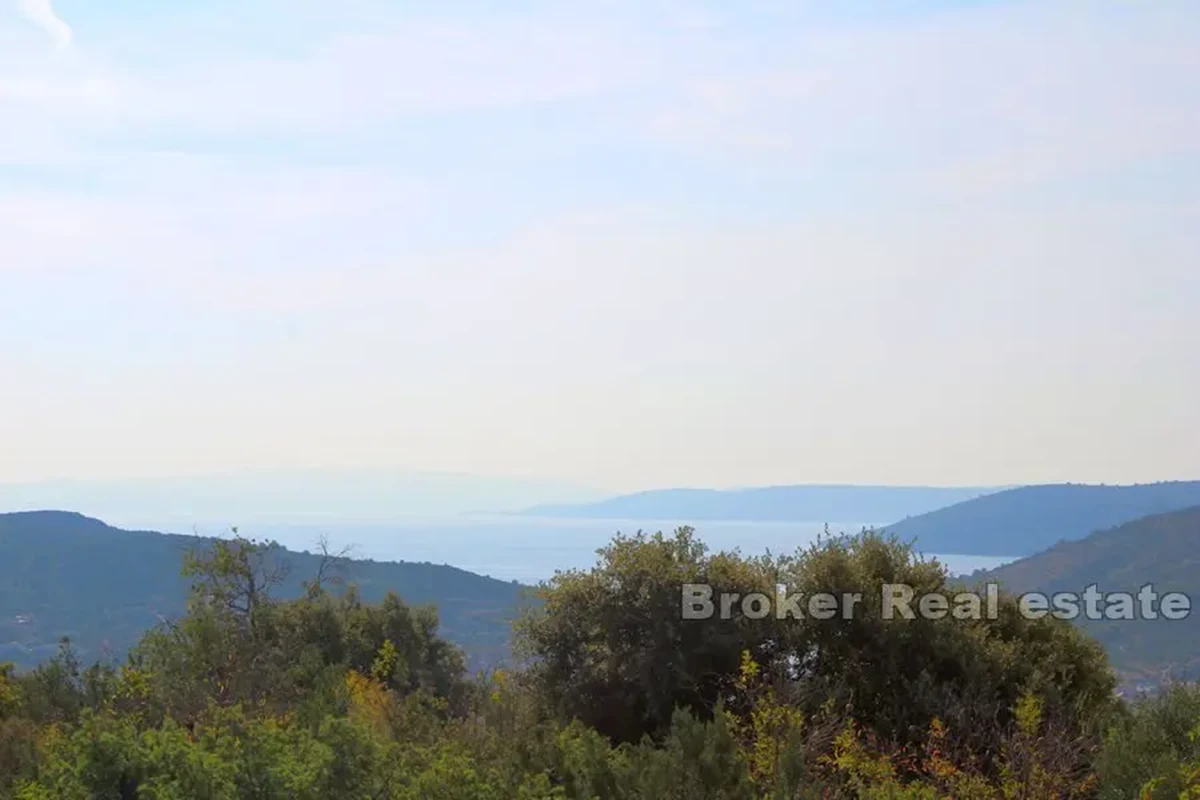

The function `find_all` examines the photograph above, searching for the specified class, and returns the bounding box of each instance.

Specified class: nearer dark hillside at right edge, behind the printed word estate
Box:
[968,505,1200,682]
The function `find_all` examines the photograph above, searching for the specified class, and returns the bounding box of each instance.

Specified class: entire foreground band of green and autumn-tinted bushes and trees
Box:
[0,529,1200,800]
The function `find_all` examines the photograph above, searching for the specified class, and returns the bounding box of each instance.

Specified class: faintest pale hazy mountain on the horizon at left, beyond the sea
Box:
[0,469,605,522]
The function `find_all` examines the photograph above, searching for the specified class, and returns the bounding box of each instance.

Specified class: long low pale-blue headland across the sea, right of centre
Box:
[521,485,996,523]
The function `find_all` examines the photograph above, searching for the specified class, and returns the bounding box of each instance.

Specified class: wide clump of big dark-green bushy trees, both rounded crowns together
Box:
[521,528,1114,782]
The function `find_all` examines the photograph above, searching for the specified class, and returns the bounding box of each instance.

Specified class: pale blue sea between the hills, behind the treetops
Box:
[107,515,1014,583]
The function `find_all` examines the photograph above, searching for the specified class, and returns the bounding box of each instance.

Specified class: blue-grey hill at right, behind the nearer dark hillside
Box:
[886,481,1200,555]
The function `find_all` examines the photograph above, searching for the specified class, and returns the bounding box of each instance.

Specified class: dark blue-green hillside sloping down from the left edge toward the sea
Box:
[0,511,524,666]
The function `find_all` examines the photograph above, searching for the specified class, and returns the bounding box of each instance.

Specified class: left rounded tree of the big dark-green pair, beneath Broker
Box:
[517,528,774,742]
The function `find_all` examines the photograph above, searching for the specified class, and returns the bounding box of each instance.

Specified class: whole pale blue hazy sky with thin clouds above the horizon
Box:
[0,0,1200,489]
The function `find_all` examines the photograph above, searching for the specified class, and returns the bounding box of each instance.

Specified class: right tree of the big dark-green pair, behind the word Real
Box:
[773,531,1115,759]
